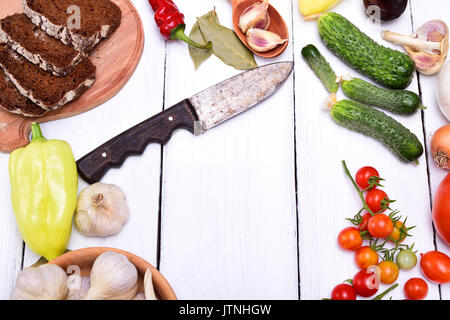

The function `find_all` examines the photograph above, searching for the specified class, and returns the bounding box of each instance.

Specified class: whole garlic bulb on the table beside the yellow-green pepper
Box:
[75,183,129,237]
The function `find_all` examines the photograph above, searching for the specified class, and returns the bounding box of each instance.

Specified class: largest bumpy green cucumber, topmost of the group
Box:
[318,12,415,89]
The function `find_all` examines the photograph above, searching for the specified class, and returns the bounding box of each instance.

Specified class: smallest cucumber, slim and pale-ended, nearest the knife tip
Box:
[302,44,339,93]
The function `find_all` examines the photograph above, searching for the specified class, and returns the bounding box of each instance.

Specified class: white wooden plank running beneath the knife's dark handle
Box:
[25,1,165,266]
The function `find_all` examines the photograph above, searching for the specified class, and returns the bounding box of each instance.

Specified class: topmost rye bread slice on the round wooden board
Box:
[23,0,122,54]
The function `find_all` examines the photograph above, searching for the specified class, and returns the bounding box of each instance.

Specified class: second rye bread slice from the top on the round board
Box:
[0,13,82,76]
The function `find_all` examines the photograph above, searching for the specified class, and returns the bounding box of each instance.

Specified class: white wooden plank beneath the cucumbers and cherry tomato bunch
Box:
[294,1,439,299]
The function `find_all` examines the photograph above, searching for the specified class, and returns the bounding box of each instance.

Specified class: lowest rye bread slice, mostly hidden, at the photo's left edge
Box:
[0,68,47,117]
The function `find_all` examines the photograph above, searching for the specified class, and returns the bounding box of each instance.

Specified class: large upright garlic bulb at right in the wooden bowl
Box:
[84,251,138,300]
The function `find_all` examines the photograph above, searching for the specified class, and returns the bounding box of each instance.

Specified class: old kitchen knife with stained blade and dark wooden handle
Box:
[77,62,294,184]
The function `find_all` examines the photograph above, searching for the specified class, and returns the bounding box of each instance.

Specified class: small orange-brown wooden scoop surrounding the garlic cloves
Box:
[231,0,289,58]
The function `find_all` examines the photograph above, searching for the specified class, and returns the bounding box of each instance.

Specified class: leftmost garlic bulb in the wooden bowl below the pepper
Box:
[11,264,68,300]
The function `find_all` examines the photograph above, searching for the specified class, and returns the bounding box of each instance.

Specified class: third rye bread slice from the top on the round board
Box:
[0,44,96,110]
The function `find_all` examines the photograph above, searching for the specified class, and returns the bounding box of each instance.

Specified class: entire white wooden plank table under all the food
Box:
[0,0,450,299]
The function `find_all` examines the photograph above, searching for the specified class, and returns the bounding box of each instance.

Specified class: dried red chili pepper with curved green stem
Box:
[148,0,211,49]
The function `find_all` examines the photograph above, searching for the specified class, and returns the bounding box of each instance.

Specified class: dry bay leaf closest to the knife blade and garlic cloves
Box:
[197,17,258,70]
